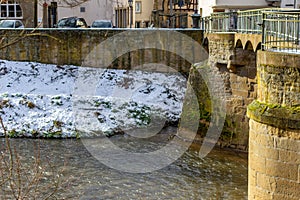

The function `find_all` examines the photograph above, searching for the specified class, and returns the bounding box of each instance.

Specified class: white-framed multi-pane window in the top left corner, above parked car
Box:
[0,0,22,19]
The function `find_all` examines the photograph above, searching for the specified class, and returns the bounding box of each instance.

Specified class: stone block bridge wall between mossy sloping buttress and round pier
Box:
[198,33,257,150]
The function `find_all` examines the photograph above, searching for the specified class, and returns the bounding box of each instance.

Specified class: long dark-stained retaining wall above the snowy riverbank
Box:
[0,29,203,73]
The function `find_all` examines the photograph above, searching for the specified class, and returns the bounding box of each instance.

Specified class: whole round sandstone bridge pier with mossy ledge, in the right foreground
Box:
[247,51,300,200]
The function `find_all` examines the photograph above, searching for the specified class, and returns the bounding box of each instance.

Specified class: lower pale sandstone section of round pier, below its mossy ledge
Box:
[248,120,300,200]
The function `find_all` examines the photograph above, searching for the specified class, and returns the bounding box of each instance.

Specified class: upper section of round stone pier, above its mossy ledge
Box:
[257,52,300,107]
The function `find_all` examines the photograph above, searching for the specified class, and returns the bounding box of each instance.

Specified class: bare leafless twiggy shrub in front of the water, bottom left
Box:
[0,116,60,200]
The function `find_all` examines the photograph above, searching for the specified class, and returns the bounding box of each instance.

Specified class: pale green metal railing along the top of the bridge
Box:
[201,8,300,52]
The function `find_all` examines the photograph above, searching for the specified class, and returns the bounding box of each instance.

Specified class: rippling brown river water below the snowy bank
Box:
[0,127,247,199]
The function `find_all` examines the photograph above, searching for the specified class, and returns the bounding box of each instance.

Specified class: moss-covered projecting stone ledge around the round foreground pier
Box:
[247,101,300,129]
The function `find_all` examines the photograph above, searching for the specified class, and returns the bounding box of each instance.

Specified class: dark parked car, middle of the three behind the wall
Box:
[55,17,88,28]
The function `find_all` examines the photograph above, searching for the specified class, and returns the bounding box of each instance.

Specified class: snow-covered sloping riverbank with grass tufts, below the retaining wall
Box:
[0,60,186,137]
